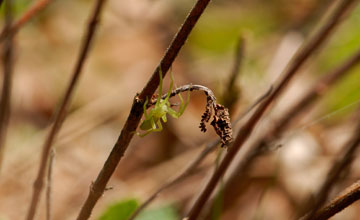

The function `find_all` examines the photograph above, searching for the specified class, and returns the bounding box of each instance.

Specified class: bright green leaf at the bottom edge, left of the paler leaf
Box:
[99,199,139,220]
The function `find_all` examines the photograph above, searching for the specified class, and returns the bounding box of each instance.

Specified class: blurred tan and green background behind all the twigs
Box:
[0,0,360,220]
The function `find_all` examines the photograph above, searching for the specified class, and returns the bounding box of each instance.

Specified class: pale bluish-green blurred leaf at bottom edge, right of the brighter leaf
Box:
[136,205,180,220]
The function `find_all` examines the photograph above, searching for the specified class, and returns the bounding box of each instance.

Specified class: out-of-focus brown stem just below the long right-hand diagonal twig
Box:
[219,44,360,215]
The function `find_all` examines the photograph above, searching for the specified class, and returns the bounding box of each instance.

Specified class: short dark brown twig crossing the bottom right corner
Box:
[314,181,360,220]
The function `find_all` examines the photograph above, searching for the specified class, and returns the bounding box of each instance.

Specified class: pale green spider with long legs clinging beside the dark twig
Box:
[137,71,190,137]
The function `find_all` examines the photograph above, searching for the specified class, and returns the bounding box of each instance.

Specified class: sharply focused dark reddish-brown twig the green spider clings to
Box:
[77,0,210,220]
